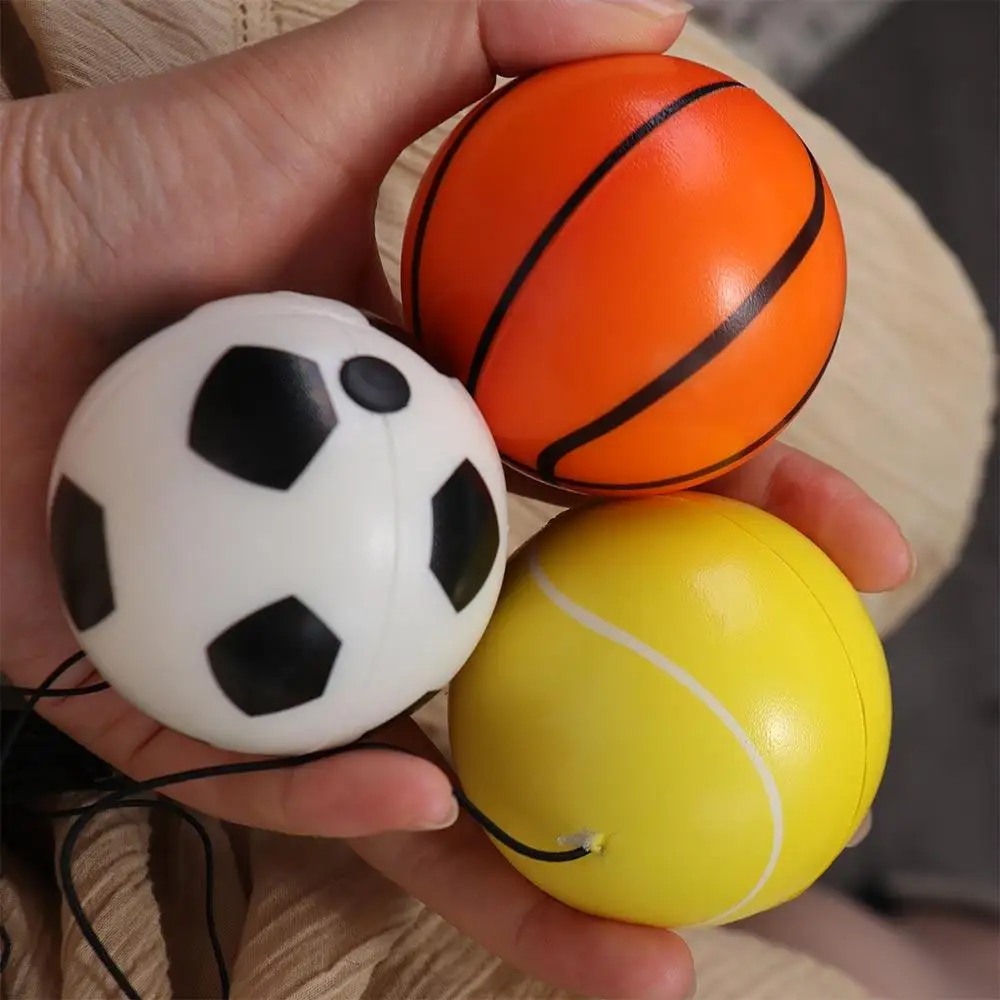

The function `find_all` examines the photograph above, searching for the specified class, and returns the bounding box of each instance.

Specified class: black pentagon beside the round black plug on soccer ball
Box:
[188,346,337,490]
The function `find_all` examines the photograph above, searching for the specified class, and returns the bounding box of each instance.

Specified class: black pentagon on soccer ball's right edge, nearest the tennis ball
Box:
[431,459,500,611]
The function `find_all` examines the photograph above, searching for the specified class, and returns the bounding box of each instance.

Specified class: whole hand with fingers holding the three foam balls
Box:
[0,0,912,1000]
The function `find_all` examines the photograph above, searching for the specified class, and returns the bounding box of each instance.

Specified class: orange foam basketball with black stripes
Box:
[402,55,846,495]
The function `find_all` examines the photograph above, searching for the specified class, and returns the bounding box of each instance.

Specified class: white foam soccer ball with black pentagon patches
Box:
[49,293,507,753]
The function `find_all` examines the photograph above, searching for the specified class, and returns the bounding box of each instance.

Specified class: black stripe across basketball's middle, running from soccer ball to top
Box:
[466,80,743,397]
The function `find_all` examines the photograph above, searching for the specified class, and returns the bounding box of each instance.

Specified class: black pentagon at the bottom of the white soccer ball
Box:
[207,597,340,716]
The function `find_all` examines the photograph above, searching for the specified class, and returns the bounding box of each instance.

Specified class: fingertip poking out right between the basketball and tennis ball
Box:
[701,444,916,593]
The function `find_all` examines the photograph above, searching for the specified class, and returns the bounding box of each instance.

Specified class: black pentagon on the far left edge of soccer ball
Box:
[49,476,115,632]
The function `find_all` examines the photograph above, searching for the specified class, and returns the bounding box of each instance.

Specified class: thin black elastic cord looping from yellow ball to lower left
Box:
[0,651,596,1000]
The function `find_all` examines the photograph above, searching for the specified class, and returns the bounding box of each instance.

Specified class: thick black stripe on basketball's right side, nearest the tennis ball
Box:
[538,147,826,481]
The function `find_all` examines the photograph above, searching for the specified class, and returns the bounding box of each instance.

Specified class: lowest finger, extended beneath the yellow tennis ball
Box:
[352,733,693,1000]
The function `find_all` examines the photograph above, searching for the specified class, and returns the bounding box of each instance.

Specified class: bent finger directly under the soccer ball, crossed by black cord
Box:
[33,674,457,837]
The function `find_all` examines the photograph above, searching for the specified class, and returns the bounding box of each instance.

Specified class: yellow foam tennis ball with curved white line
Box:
[450,493,891,928]
